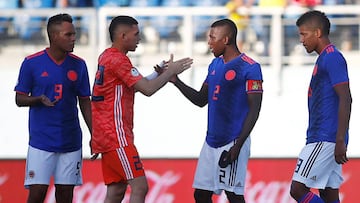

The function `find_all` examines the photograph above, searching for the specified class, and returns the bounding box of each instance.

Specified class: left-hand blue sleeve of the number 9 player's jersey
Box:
[14,59,33,94]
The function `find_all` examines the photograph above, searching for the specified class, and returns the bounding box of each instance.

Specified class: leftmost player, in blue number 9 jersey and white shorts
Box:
[15,14,91,203]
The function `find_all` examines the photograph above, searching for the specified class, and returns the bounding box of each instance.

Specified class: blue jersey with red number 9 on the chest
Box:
[15,50,90,152]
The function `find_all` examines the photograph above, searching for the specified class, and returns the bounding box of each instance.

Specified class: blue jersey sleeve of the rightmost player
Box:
[326,52,349,86]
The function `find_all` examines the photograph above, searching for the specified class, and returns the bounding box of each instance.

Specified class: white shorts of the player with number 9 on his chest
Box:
[24,146,82,188]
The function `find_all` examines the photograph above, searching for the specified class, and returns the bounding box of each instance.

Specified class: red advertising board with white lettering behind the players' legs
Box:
[0,159,360,203]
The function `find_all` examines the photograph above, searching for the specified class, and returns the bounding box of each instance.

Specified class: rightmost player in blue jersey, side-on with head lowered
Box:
[290,10,352,203]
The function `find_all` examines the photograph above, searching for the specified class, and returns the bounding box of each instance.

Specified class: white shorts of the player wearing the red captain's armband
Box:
[193,137,251,195]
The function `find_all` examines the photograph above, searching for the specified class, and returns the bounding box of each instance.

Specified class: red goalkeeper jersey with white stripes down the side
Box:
[91,48,142,153]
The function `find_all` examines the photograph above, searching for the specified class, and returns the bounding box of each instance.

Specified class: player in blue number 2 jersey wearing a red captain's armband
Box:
[173,19,263,203]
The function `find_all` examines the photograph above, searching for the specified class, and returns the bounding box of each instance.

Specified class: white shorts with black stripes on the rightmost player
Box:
[293,142,343,189]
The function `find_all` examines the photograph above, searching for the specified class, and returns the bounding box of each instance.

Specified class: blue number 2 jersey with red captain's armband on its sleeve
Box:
[205,54,262,147]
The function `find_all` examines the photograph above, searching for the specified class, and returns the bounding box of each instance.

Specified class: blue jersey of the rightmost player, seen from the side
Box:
[306,45,349,143]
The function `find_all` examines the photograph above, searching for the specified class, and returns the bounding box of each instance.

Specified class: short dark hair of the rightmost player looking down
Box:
[296,10,330,35]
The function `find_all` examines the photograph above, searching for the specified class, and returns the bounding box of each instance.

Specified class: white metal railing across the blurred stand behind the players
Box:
[0,5,360,68]
